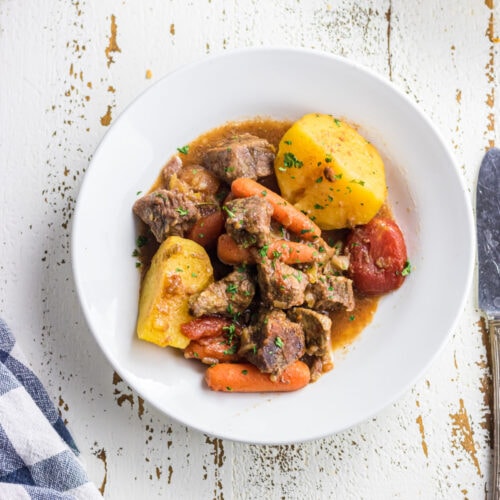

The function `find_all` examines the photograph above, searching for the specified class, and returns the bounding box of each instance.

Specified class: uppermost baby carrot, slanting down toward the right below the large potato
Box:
[231,177,321,240]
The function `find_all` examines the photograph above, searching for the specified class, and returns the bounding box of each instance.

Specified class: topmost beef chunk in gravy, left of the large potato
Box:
[203,134,275,184]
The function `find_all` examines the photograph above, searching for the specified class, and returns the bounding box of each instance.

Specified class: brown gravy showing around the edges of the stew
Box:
[141,118,376,349]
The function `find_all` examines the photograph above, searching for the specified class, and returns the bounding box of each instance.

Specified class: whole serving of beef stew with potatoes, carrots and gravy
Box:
[133,114,410,392]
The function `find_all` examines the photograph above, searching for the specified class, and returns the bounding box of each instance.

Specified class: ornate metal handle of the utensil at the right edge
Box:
[486,317,500,500]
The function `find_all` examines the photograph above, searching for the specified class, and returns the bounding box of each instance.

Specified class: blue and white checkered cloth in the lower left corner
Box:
[0,319,102,500]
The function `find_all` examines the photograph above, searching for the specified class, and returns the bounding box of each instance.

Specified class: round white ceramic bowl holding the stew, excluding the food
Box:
[72,49,474,444]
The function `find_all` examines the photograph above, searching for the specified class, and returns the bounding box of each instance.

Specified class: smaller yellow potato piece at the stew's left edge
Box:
[137,236,213,349]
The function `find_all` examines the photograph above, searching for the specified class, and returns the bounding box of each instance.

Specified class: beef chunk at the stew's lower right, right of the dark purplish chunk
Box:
[287,307,332,357]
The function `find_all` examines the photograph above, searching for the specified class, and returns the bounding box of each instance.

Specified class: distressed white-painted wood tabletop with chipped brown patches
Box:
[0,0,500,499]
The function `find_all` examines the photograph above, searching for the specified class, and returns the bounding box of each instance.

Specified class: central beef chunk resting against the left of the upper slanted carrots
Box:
[225,196,273,247]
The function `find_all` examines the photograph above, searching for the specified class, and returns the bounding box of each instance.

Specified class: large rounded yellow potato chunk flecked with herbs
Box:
[275,113,387,229]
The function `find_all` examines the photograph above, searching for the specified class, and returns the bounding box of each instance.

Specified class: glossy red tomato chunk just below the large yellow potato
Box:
[347,217,408,295]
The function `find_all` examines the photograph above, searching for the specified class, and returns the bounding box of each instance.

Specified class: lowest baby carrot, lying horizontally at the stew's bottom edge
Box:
[205,361,311,392]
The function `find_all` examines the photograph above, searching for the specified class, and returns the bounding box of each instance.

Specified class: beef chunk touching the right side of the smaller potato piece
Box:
[189,270,255,317]
